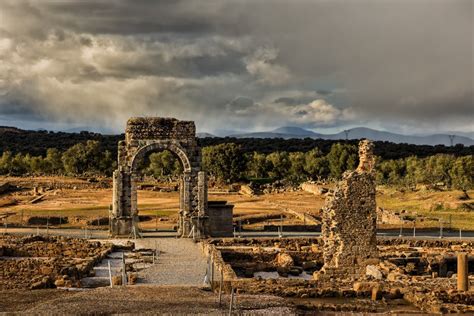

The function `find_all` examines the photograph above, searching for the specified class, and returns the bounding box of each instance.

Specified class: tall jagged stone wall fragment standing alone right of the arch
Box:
[317,140,378,279]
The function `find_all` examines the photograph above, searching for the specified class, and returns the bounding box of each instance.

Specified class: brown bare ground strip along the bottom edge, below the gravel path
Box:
[0,286,296,315]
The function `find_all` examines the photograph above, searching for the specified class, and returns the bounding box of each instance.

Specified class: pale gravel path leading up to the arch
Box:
[136,238,207,286]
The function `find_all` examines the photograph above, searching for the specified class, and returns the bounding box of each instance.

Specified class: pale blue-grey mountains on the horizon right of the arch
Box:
[229,126,474,146]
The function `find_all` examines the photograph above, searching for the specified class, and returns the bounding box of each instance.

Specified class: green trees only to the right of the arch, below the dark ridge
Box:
[203,143,474,190]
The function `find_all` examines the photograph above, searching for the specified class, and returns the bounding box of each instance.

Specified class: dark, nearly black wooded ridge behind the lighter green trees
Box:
[0,127,474,160]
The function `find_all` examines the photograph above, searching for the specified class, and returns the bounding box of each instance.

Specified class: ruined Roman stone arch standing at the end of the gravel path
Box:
[110,117,208,237]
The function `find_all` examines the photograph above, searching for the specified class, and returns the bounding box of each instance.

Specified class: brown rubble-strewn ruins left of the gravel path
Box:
[0,235,112,289]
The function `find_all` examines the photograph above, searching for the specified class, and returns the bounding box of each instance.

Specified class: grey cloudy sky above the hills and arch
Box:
[0,0,474,133]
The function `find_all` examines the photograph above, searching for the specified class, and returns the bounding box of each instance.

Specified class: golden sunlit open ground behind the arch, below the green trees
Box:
[0,177,474,230]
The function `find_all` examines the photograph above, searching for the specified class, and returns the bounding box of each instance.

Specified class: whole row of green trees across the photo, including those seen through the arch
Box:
[0,140,474,190]
